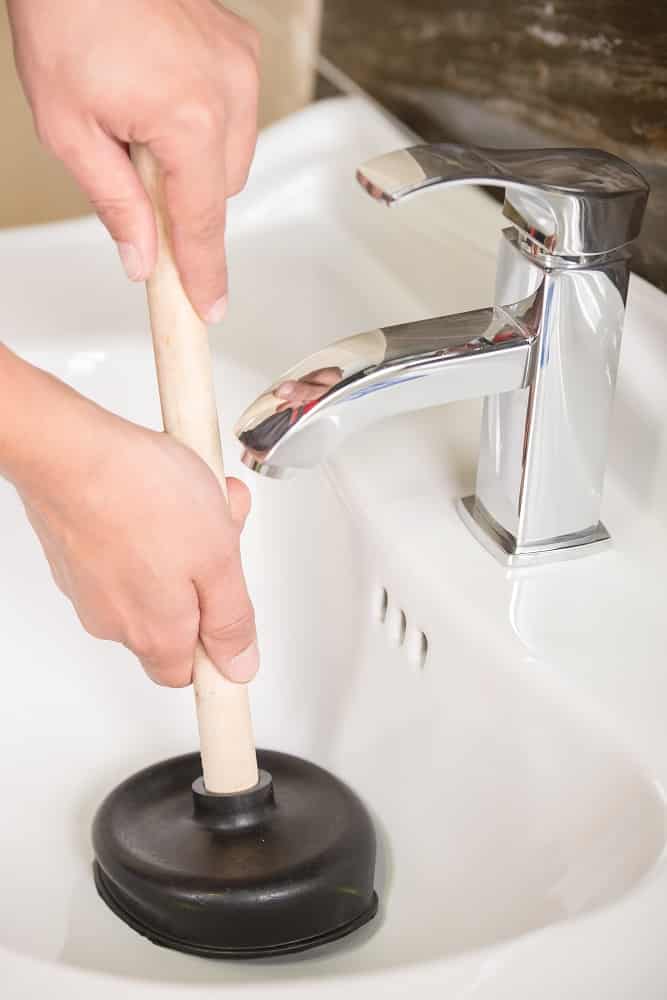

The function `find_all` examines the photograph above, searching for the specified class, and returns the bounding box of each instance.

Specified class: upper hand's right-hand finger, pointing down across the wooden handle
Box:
[150,115,227,323]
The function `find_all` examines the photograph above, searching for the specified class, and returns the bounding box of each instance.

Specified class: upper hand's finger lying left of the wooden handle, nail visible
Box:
[52,126,156,281]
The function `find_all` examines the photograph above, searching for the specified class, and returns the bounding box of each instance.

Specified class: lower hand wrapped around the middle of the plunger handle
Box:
[9,359,258,687]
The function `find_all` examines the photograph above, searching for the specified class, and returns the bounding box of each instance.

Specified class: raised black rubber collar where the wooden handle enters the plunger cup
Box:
[192,770,276,833]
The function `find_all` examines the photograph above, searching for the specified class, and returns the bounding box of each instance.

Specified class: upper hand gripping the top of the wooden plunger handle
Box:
[8,0,259,323]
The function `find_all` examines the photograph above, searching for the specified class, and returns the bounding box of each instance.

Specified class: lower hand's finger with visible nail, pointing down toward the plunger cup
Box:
[196,549,259,683]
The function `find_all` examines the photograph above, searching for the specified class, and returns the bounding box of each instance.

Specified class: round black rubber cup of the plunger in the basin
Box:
[93,750,377,958]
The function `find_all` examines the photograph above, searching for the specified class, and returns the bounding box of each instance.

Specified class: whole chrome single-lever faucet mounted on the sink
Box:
[236,144,648,563]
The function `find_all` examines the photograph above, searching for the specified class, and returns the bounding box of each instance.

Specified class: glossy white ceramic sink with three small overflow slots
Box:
[0,98,667,1000]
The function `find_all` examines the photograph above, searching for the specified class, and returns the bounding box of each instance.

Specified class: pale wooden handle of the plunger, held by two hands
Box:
[132,146,257,792]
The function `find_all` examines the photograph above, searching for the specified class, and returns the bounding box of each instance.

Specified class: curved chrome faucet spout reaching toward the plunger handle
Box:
[236,290,541,478]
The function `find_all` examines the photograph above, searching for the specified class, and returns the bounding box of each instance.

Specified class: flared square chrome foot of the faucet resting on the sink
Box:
[456,495,611,567]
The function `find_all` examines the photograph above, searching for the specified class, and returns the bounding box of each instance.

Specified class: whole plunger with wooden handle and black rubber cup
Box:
[93,147,377,958]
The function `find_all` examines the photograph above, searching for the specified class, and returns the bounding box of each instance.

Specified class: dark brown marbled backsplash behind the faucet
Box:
[322,0,667,290]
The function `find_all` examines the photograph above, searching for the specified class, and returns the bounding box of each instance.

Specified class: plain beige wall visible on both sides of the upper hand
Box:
[0,0,321,226]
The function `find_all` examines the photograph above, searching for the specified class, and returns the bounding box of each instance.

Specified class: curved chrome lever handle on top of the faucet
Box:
[357,143,649,257]
